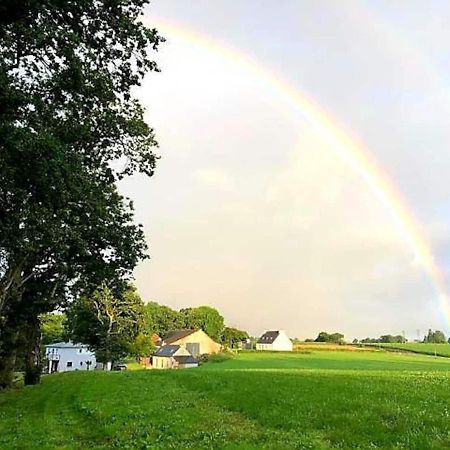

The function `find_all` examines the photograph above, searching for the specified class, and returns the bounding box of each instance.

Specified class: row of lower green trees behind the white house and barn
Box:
[41,284,248,363]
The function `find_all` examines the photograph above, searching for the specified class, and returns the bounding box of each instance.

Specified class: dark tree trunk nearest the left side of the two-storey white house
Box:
[24,315,42,385]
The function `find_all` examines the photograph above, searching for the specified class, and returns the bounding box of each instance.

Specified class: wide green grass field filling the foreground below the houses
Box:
[0,351,450,450]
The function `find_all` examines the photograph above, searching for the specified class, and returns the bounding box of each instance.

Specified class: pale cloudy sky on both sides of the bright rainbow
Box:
[120,0,450,338]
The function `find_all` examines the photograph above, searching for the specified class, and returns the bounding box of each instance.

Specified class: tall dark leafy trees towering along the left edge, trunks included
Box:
[0,0,162,388]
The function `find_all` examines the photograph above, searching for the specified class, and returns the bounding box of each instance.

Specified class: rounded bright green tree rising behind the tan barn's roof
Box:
[180,306,224,341]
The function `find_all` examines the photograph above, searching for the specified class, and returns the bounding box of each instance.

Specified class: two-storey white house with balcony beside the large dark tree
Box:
[45,342,96,373]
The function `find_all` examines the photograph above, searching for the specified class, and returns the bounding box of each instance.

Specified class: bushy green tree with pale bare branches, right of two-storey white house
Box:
[67,285,145,363]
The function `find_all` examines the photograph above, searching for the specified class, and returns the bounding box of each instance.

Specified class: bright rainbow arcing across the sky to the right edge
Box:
[144,17,450,328]
